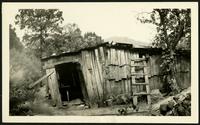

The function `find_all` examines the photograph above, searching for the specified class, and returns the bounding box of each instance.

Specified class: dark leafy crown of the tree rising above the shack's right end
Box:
[138,9,191,49]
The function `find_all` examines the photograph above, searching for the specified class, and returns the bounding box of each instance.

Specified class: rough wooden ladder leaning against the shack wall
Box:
[131,56,151,106]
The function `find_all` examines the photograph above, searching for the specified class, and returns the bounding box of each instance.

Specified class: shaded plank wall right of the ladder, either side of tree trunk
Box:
[148,55,191,90]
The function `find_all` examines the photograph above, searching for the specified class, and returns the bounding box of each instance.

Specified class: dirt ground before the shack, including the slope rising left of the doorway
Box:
[30,85,150,116]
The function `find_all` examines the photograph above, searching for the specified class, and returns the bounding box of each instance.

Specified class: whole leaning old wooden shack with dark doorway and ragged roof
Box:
[42,43,191,105]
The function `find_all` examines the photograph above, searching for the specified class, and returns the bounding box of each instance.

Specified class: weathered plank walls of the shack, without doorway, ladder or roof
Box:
[44,46,191,103]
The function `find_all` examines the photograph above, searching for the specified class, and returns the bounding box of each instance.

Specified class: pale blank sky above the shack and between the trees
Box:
[9,3,156,43]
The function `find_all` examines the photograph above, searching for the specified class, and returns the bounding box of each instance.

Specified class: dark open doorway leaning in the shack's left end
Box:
[56,63,85,101]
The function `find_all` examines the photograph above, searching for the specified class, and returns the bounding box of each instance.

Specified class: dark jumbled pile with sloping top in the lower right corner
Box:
[151,88,191,116]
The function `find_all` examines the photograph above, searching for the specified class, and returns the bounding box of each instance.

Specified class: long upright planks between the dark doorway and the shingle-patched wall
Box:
[81,48,105,103]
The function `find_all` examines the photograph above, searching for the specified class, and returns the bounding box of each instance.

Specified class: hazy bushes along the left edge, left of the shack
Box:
[10,26,41,115]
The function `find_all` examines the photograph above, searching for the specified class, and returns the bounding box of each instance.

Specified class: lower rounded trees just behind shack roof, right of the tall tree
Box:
[43,23,103,55]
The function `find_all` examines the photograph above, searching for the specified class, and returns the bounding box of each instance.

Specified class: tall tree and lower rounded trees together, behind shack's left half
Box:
[15,9,102,57]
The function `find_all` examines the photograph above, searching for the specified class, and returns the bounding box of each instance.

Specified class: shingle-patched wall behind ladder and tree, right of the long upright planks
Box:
[104,48,191,98]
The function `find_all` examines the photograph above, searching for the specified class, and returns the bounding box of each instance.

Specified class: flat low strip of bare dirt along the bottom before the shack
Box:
[34,105,150,116]
